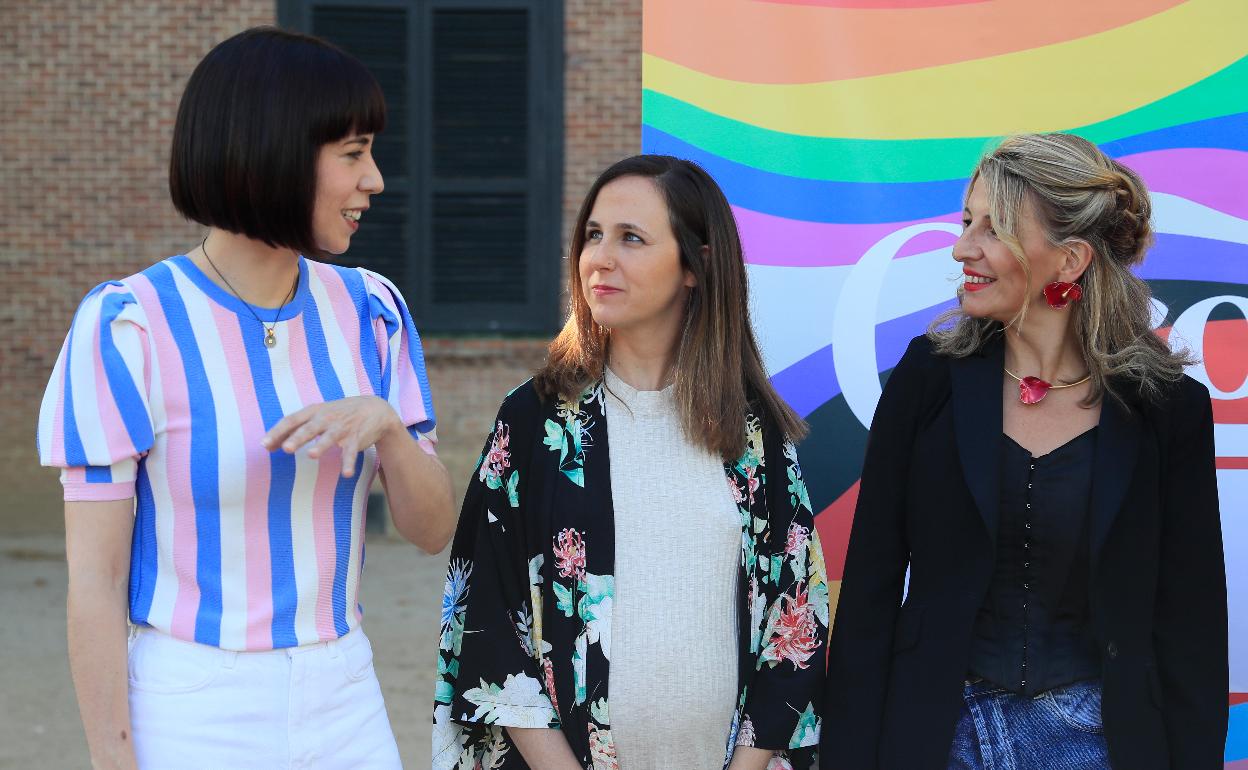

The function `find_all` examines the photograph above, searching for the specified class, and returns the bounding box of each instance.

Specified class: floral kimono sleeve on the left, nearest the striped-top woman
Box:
[433,386,559,768]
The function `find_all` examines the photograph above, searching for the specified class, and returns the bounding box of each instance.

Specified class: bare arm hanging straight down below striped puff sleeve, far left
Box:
[65,498,139,770]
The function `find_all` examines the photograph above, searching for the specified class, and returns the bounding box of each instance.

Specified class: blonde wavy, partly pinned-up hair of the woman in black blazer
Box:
[927,134,1194,406]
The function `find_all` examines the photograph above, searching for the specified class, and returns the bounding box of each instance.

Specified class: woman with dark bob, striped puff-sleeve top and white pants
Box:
[39,27,454,768]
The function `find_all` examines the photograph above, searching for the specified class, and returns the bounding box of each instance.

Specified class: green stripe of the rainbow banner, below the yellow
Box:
[641,57,1248,182]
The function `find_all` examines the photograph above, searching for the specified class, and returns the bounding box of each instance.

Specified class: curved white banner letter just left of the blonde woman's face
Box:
[832,222,962,427]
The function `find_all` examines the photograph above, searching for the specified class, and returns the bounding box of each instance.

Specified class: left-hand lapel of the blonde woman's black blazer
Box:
[950,337,1005,548]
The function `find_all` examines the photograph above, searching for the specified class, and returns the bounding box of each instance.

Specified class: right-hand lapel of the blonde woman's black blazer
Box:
[1090,394,1142,574]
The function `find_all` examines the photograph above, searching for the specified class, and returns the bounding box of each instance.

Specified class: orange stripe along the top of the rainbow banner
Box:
[641,0,1181,84]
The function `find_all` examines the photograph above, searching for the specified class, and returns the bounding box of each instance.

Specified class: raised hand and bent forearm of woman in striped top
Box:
[263,396,456,553]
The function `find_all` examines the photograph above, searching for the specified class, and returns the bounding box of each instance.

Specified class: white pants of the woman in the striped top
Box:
[130,628,402,770]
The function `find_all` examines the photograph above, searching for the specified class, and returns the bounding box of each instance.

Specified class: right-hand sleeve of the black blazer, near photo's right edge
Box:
[1153,378,1229,770]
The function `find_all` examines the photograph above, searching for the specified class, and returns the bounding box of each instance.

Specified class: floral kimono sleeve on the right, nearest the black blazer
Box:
[736,428,830,768]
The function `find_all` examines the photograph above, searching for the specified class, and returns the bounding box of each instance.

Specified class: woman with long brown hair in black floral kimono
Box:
[433,155,829,770]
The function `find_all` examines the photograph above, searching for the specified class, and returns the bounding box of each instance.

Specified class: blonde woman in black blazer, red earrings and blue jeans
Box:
[821,134,1228,770]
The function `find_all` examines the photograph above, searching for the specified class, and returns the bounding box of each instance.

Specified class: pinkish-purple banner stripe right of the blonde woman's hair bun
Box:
[1118,149,1248,218]
